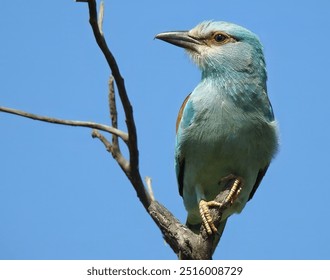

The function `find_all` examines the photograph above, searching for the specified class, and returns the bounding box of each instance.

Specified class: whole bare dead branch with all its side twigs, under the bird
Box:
[0,0,235,259]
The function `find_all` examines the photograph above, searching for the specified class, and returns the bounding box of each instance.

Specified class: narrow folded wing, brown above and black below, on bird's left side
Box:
[175,93,192,196]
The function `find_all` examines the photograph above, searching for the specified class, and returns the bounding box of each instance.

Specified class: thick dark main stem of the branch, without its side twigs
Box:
[75,0,226,259]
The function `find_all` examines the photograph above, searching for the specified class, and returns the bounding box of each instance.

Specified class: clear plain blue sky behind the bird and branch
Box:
[0,0,330,259]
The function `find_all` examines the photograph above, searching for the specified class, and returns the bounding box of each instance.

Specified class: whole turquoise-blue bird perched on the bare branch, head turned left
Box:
[156,21,278,249]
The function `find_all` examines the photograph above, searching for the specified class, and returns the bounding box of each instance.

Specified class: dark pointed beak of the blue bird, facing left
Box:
[155,31,203,52]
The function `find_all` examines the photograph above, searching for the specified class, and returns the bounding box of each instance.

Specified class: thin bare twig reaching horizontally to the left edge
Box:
[0,107,128,143]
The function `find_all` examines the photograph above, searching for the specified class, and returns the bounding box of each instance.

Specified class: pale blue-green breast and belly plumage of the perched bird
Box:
[180,95,272,185]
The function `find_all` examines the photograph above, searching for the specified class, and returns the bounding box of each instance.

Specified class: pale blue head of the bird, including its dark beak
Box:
[156,21,266,76]
